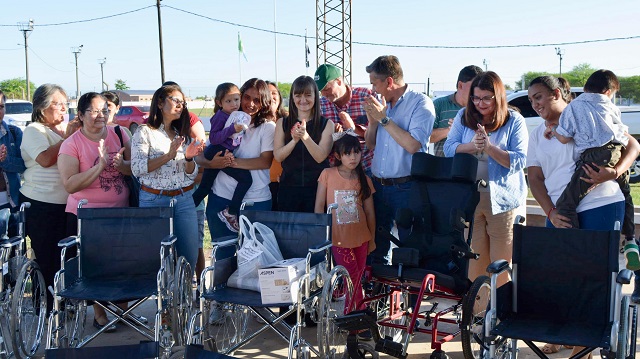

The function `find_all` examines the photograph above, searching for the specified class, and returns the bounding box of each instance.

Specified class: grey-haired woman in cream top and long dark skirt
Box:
[20,84,80,309]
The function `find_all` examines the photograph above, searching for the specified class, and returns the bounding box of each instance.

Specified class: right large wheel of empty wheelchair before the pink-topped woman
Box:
[171,257,193,346]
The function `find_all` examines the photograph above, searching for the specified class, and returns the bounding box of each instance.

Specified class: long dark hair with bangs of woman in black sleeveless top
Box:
[282,76,324,143]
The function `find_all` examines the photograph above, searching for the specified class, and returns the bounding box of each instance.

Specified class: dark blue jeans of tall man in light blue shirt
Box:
[370,181,421,264]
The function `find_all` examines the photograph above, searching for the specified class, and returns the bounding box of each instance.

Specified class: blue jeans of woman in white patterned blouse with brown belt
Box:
[140,190,199,269]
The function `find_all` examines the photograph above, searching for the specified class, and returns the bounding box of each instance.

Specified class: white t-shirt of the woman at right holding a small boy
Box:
[527,123,624,212]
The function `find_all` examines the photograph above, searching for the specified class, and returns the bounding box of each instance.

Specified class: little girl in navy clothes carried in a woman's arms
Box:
[193,82,253,232]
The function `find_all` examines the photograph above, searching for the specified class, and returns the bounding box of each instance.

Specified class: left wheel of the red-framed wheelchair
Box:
[369,283,409,343]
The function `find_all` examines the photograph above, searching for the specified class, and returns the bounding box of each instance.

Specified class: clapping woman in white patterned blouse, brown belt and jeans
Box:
[131,85,203,268]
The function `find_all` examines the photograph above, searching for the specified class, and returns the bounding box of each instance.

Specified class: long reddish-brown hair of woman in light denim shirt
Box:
[462,71,509,132]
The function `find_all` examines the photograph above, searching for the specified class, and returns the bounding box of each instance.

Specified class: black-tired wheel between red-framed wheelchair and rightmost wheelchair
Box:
[460,276,491,359]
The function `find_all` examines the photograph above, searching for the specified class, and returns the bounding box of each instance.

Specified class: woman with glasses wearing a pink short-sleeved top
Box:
[58,92,131,333]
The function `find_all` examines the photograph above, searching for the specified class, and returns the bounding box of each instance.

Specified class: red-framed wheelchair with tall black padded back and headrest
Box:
[334,153,483,359]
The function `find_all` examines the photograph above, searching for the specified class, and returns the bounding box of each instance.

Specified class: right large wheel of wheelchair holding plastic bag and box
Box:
[318,266,354,359]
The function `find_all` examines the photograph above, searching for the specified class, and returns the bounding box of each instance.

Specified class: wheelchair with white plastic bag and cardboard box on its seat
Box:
[189,206,353,358]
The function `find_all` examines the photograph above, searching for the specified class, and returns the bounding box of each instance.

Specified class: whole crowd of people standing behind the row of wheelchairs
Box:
[0,56,640,352]
